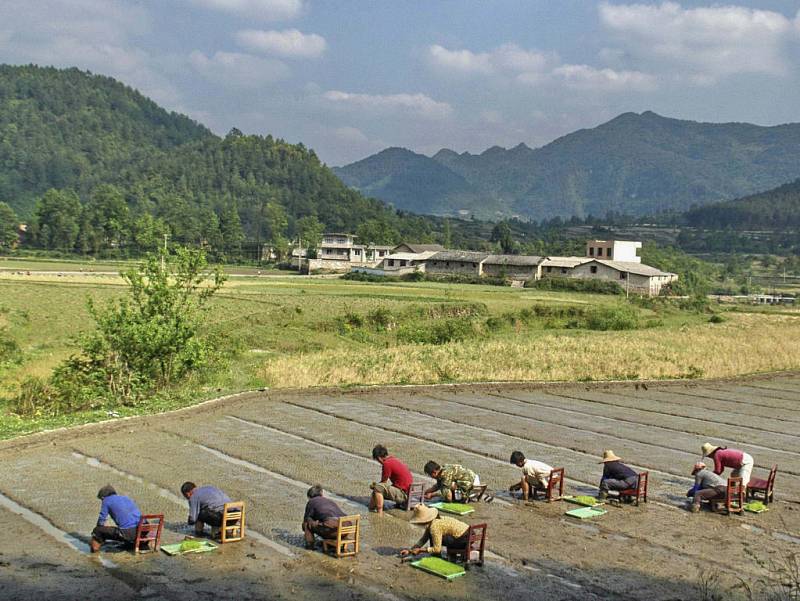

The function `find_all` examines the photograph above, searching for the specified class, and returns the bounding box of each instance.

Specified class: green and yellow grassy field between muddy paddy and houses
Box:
[0,273,800,437]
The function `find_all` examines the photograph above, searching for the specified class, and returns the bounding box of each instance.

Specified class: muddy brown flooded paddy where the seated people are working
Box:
[0,374,800,601]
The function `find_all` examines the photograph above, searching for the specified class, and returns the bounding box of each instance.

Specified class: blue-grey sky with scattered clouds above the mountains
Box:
[0,0,800,165]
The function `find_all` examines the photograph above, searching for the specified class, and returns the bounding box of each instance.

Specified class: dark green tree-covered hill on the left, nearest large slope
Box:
[0,66,432,257]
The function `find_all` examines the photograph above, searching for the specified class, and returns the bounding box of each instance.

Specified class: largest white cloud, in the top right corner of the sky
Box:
[600,2,797,81]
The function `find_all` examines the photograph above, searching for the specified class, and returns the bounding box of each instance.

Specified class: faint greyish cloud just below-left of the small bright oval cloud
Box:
[189,50,289,88]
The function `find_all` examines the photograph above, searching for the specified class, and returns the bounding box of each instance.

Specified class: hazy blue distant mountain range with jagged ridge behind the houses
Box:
[335,112,800,220]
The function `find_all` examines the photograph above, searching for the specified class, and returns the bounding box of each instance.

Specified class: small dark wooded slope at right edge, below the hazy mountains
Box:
[682,179,800,230]
